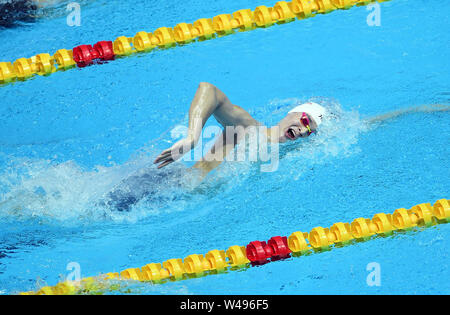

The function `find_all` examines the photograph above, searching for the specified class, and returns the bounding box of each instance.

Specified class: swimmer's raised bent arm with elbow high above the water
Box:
[154,82,258,168]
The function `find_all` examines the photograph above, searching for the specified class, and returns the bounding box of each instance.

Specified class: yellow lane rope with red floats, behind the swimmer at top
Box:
[0,0,389,84]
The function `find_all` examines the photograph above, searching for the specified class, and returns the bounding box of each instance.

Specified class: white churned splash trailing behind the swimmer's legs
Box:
[0,154,153,221]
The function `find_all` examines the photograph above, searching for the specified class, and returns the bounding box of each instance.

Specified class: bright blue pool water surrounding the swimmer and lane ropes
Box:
[0,0,450,294]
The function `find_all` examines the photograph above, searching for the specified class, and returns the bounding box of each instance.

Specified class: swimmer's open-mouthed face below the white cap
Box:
[278,113,317,143]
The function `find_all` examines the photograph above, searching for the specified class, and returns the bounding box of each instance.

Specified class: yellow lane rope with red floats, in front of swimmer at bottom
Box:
[21,199,450,295]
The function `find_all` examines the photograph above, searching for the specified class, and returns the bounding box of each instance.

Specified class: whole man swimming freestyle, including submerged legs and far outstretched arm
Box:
[109,83,450,211]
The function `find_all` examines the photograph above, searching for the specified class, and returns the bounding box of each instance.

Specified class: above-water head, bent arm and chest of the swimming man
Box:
[154,82,326,176]
